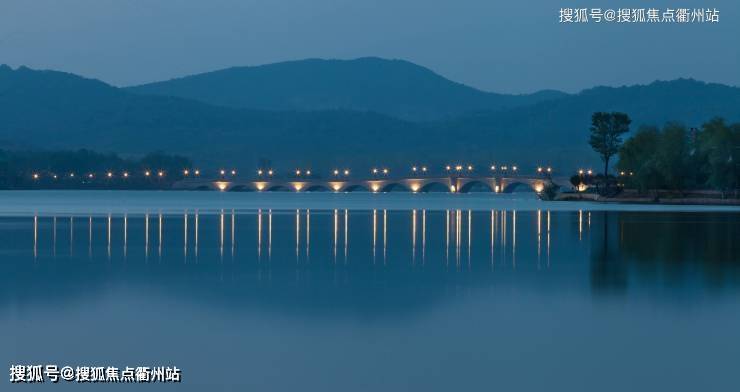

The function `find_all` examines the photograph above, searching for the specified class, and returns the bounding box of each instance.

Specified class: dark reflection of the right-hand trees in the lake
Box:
[591,212,740,291]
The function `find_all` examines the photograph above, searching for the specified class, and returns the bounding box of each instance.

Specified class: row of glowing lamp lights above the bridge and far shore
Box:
[27,165,572,180]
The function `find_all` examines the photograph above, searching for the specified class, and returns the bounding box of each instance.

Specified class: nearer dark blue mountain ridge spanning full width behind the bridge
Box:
[0,62,740,170]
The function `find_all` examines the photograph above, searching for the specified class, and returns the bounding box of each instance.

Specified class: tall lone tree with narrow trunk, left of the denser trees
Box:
[589,112,632,177]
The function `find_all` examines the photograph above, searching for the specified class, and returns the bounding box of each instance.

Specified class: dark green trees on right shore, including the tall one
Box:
[589,112,740,193]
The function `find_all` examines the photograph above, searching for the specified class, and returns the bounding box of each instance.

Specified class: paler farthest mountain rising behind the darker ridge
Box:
[128,57,566,121]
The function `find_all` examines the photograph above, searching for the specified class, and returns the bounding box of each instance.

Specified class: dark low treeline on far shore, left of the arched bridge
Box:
[0,149,192,189]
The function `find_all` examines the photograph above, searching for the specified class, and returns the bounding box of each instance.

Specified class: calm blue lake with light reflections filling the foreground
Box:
[0,191,740,391]
